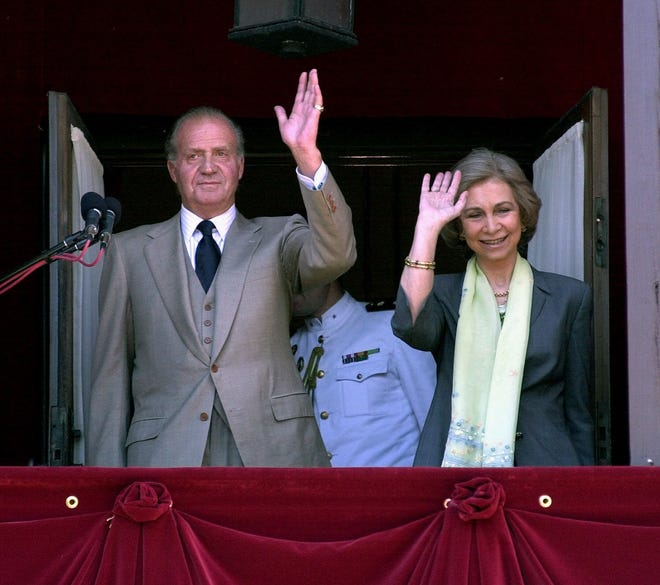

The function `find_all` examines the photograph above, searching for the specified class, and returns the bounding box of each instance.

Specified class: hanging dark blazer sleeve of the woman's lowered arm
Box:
[564,285,595,465]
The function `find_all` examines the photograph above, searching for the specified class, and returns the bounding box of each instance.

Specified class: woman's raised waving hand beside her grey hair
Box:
[419,171,467,229]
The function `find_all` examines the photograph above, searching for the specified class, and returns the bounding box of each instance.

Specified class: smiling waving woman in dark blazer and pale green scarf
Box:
[392,149,594,467]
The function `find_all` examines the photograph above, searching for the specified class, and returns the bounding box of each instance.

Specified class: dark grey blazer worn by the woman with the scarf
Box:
[392,268,594,466]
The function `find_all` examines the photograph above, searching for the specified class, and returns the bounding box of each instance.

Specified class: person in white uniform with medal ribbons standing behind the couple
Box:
[291,281,436,467]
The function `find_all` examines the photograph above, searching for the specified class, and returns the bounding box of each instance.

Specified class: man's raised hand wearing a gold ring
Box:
[275,69,323,176]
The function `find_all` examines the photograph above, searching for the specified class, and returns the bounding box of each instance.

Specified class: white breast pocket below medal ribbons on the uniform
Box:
[337,356,388,416]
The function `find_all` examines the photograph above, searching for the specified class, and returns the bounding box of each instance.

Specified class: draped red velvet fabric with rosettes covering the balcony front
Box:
[0,467,660,585]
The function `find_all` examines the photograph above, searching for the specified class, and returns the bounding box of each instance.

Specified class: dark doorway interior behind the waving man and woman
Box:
[86,116,556,301]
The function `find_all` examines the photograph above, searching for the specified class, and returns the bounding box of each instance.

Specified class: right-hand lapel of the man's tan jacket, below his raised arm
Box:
[212,213,261,361]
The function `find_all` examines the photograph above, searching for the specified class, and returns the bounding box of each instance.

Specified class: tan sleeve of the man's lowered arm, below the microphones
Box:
[85,238,134,467]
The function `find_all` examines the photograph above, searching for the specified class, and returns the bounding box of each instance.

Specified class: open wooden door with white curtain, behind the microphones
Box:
[44,91,104,466]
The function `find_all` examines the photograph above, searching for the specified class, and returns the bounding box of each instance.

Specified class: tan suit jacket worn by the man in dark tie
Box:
[85,174,356,467]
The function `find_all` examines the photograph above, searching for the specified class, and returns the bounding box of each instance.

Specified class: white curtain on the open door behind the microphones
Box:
[69,126,105,464]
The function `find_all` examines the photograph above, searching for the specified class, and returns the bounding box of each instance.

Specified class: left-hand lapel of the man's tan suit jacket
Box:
[144,214,208,363]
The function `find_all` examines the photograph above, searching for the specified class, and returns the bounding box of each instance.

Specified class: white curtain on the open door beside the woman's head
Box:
[527,121,584,280]
